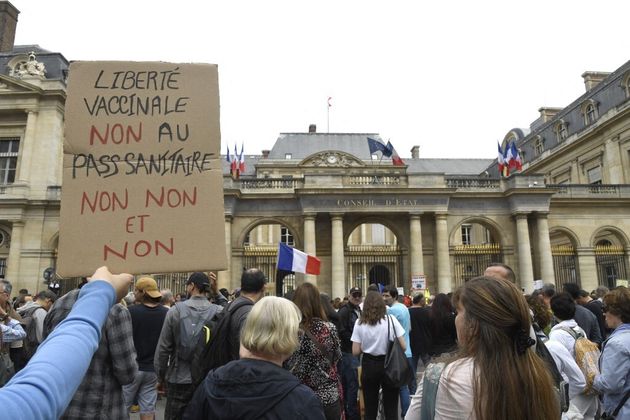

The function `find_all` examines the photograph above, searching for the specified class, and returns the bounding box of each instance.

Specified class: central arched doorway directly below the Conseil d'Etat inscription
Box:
[345,223,402,291]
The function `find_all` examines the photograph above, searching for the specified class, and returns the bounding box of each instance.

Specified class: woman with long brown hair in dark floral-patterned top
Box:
[285,283,342,420]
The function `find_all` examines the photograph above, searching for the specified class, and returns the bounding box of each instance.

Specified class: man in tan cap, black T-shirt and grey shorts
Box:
[123,277,168,420]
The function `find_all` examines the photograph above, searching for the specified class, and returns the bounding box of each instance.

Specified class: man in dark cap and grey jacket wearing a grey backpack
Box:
[153,272,223,420]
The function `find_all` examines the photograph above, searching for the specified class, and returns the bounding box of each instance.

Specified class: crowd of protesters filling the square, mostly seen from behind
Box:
[0,264,630,420]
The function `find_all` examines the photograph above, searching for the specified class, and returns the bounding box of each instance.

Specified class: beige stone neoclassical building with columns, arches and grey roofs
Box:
[0,2,630,297]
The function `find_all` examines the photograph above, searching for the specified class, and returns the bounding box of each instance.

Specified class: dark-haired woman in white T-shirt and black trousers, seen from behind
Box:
[351,291,406,420]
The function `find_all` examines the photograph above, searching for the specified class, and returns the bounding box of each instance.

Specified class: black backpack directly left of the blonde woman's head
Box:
[191,299,254,386]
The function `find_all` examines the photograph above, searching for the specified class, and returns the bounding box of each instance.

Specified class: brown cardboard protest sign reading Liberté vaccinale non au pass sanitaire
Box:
[57,62,227,277]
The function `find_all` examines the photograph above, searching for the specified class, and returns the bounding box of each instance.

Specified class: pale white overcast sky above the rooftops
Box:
[10,0,630,158]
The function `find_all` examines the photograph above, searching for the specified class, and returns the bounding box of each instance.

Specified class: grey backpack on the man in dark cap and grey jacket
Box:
[175,302,219,362]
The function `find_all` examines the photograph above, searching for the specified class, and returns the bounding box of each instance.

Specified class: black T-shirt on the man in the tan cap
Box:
[129,304,168,372]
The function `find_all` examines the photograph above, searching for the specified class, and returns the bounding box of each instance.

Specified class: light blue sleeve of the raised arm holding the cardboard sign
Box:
[0,280,116,420]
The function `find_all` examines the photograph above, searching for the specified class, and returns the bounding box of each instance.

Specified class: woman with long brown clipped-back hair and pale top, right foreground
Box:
[405,277,560,420]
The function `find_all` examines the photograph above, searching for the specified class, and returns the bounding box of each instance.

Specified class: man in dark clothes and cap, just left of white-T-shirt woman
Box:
[339,287,363,420]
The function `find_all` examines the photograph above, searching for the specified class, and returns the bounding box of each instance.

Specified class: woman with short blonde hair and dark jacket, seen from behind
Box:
[183,296,324,420]
